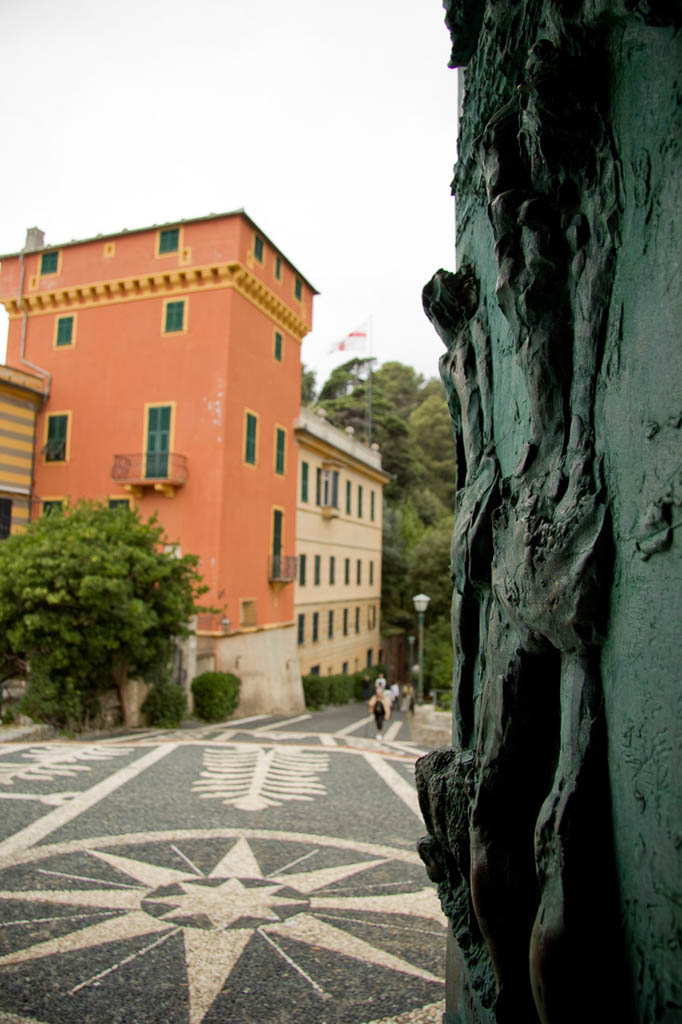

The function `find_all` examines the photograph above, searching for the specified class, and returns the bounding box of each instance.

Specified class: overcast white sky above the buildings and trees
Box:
[0,0,457,385]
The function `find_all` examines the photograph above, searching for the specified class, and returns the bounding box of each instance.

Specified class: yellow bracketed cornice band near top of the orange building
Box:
[2,262,309,341]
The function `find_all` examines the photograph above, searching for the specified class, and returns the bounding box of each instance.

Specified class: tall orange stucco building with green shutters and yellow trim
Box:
[0,211,315,713]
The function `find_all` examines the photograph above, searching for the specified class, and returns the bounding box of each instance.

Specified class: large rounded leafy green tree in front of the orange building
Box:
[0,502,207,726]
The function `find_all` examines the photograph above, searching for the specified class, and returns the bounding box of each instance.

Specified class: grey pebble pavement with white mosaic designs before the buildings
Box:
[0,705,445,1024]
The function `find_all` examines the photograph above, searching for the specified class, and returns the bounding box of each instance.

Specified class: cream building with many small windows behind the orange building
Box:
[294,409,389,676]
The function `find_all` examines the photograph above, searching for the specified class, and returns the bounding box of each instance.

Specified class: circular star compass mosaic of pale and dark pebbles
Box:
[0,829,445,1024]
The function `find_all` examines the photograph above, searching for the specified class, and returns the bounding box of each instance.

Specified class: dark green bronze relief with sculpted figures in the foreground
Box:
[417,0,682,1024]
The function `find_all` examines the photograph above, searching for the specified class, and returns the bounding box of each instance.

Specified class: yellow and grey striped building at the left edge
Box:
[0,366,44,539]
